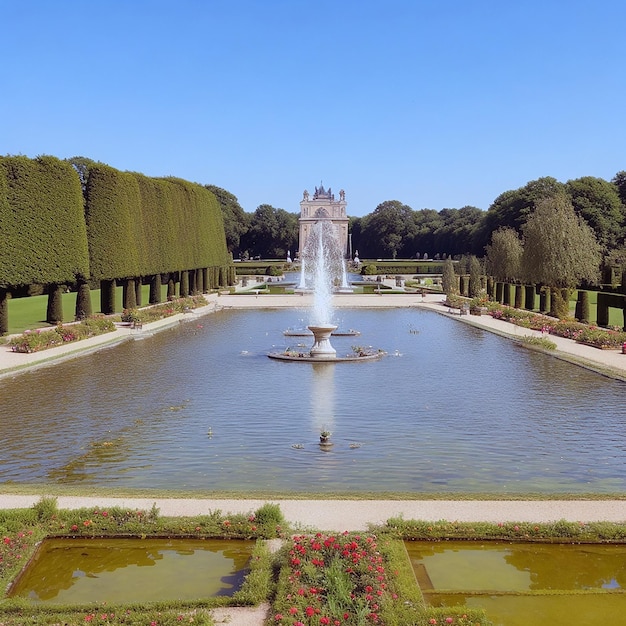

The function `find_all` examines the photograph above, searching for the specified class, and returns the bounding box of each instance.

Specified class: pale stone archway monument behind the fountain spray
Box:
[298,183,348,258]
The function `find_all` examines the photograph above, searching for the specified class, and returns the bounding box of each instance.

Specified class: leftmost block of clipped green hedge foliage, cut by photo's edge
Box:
[0,156,89,286]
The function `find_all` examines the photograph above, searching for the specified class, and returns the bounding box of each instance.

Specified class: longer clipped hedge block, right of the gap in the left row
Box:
[86,164,231,280]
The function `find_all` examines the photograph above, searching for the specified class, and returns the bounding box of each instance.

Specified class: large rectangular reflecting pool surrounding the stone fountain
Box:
[0,309,626,493]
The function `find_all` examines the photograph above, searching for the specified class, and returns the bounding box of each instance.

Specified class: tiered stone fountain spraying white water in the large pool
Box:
[268,218,383,362]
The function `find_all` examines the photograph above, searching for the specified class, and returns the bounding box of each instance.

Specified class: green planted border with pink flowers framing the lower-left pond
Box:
[0,497,284,626]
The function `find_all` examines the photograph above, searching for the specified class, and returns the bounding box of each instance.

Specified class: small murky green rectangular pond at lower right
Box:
[405,541,626,626]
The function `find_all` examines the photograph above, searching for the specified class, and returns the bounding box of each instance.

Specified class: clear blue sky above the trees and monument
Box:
[0,0,626,216]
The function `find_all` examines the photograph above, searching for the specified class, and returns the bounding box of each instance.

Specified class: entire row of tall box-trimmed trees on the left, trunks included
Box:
[0,156,234,334]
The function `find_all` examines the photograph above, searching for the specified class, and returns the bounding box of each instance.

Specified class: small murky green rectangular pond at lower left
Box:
[8,538,254,604]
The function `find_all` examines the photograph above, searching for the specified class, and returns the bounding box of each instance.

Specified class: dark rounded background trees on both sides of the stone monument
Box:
[212,171,626,259]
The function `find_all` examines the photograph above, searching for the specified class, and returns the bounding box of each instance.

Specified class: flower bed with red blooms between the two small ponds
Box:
[273,532,446,626]
